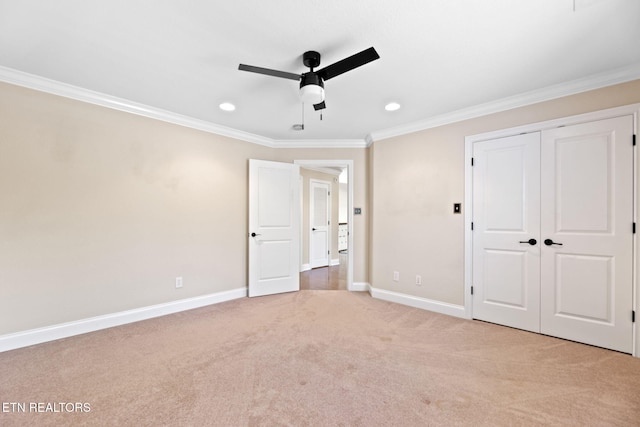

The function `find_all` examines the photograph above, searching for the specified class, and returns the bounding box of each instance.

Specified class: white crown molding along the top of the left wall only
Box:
[0,66,274,147]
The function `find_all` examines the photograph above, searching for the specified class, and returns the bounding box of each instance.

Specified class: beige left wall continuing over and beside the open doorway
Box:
[0,83,368,335]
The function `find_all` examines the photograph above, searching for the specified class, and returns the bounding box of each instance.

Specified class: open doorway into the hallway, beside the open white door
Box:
[294,160,354,290]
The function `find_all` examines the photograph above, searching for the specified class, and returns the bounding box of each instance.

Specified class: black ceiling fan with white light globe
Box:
[238,47,380,111]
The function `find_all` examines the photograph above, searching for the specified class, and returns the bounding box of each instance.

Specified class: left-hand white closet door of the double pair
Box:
[473,132,540,332]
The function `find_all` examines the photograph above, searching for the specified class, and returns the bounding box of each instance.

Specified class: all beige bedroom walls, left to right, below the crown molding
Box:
[0,76,640,335]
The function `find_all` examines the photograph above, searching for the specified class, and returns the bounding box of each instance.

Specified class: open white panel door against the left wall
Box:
[249,159,300,297]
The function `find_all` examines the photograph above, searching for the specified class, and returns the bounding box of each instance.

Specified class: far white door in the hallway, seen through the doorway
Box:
[309,179,331,268]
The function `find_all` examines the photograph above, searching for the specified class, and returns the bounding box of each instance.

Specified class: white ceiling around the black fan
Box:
[0,0,640,141]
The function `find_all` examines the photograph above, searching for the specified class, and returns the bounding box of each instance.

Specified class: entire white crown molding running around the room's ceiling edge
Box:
[0,63,640,148]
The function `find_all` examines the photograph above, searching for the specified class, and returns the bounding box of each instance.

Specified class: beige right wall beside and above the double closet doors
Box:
[370,80,640,305]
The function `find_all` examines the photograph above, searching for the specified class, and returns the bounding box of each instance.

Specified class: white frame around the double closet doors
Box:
[464,104,640,357]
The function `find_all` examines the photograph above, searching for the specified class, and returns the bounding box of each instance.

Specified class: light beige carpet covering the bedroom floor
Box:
[0,291,640,426]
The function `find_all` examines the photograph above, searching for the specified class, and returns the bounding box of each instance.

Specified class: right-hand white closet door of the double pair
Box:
[540,116,633,353]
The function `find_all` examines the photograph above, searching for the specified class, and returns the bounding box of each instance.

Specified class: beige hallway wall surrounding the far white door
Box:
[300,168,340,264]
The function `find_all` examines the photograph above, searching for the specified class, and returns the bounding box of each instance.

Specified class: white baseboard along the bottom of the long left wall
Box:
[0,288,247,352]
